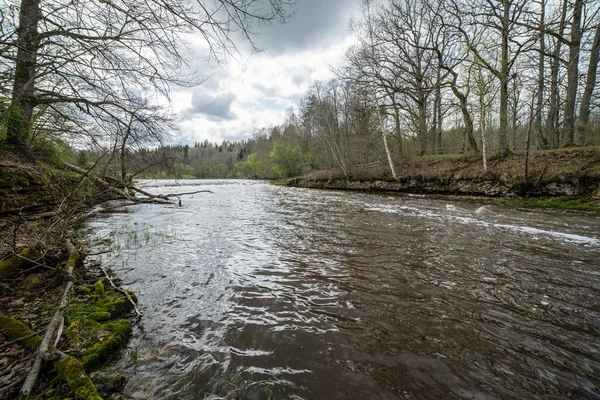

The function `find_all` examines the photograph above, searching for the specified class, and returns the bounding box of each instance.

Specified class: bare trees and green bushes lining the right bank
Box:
[138,0,600,178]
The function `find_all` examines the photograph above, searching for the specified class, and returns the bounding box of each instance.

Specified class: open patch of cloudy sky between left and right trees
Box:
[172,0,361,144]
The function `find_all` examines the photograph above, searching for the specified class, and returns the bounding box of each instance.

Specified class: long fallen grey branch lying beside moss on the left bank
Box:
[21,241,79,397]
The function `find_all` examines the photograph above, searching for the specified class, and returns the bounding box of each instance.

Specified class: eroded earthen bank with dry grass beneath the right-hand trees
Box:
[285,148,600,208]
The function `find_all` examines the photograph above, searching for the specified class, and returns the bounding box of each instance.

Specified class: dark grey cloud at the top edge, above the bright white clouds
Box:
[258,0,361,54]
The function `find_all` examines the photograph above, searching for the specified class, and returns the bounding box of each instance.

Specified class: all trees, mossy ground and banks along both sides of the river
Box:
[0,0,600,399]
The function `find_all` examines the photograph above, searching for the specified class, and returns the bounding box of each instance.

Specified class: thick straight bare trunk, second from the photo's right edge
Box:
[563,0,583,145]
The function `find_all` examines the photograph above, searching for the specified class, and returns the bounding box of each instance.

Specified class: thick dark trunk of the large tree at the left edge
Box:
[6,0,41,153]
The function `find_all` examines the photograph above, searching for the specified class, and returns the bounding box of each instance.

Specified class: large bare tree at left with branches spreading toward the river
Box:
[0,0,295,153]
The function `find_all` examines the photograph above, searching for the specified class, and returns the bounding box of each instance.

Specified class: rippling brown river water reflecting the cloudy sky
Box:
[90,180,600,399]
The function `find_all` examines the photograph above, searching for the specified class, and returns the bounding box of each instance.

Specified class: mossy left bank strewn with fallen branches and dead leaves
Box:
[0,158,141,400]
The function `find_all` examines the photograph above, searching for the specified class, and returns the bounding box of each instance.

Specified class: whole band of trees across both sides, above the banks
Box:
[0,0,600,178]
